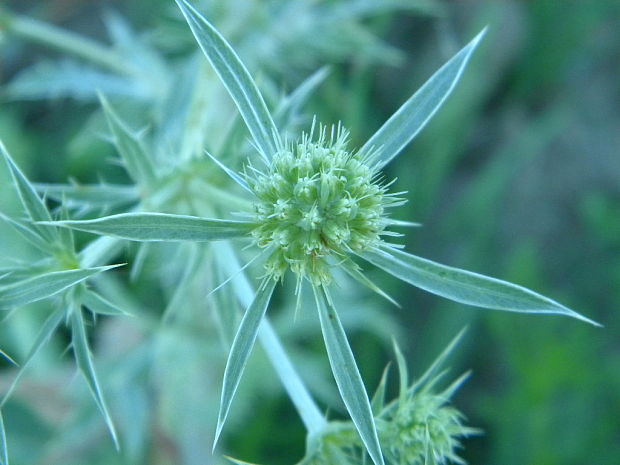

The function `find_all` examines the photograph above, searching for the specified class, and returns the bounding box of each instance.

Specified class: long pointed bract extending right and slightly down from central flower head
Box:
[359,248,600,326]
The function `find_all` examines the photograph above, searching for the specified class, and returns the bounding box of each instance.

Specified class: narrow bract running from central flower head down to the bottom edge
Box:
[312,286,384,465]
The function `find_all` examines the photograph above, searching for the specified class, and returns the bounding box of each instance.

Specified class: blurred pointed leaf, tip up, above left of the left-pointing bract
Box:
[99,94,157,186]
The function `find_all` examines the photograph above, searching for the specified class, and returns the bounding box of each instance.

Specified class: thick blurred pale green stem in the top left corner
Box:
[0,7,137,75]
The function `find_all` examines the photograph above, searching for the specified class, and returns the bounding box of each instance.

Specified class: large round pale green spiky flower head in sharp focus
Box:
[249,126,399,284]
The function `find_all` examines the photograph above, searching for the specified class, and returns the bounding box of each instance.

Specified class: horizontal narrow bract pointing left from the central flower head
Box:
[42,213,254,242]
